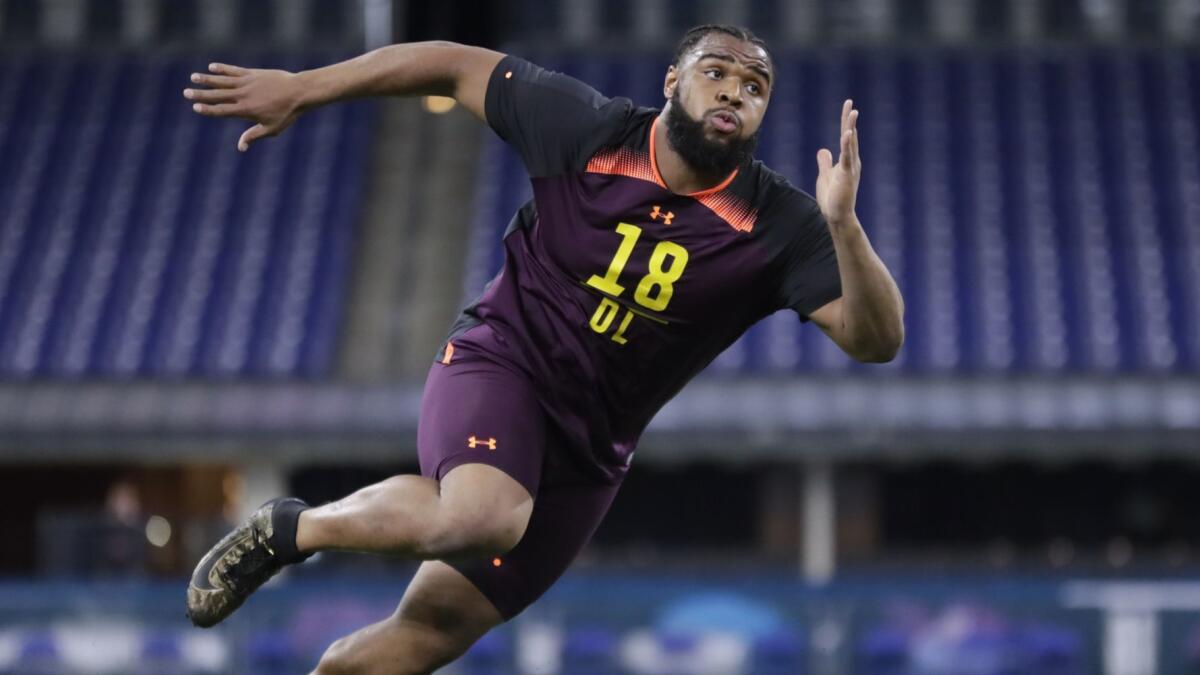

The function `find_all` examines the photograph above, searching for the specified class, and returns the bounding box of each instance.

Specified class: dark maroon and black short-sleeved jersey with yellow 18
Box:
[438,56,841,480]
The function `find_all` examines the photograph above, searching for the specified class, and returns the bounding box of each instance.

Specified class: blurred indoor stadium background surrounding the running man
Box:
[0,0,1200,675]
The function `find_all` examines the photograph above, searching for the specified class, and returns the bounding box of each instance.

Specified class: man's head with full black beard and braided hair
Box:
[662,24,775,174]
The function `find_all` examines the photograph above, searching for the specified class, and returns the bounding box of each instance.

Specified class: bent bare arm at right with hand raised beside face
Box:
[809,101,904,362]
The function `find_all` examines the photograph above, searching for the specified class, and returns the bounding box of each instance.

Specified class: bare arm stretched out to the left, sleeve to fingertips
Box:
[184,42,504,151]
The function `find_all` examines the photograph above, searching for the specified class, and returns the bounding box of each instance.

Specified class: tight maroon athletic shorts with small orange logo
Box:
[416,333,620,620]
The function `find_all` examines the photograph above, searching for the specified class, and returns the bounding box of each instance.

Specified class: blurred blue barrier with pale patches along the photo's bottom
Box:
[0,568,1104,675]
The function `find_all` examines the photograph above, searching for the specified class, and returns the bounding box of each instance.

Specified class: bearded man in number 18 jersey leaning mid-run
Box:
[184,25,904,675]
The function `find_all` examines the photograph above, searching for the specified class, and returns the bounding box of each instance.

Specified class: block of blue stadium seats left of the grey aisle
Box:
[0,52,372,378]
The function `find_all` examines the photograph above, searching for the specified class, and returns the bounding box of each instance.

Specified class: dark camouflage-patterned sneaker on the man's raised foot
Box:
[187,497,307,628]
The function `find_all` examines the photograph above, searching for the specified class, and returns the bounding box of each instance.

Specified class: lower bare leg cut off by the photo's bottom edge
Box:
[313,561,503,675]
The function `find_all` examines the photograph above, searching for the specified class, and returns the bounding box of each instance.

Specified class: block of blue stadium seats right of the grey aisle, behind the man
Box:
[466,50,1200,375]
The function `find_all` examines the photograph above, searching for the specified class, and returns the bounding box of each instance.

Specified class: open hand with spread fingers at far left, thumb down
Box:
[184,64,304,153]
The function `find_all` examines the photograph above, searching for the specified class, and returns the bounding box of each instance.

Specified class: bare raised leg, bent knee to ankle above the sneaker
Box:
[296,464,533,560]
